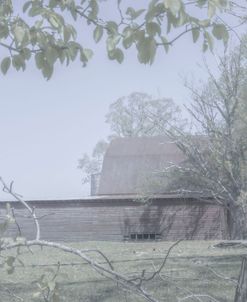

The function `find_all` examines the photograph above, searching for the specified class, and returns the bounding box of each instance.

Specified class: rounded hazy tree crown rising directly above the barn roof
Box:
[106,92,180,137]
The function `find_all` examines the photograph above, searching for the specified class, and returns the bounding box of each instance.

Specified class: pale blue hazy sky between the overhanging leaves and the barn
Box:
[0,13,239,199]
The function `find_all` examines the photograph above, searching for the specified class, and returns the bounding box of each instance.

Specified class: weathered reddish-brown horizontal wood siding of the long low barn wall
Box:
[0,200,227,241]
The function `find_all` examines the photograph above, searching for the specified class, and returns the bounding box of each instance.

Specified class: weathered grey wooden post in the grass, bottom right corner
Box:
[234,257,247,302]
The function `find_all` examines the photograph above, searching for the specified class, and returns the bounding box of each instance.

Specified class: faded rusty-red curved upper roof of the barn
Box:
[98,136,184,195]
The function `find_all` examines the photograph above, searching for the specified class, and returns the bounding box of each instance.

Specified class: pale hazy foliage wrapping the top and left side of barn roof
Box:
[79,92,184,183]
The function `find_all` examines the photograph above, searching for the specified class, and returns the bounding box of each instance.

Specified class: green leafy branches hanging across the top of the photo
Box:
[0,0,239,79]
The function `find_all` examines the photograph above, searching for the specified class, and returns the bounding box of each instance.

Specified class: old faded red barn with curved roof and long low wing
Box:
[0,137,227,241]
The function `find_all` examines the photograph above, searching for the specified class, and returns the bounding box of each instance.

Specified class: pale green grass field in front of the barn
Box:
[0,241,247,302]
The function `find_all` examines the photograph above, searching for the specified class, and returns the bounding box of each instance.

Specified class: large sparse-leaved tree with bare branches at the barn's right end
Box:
[165,41,247,239]
